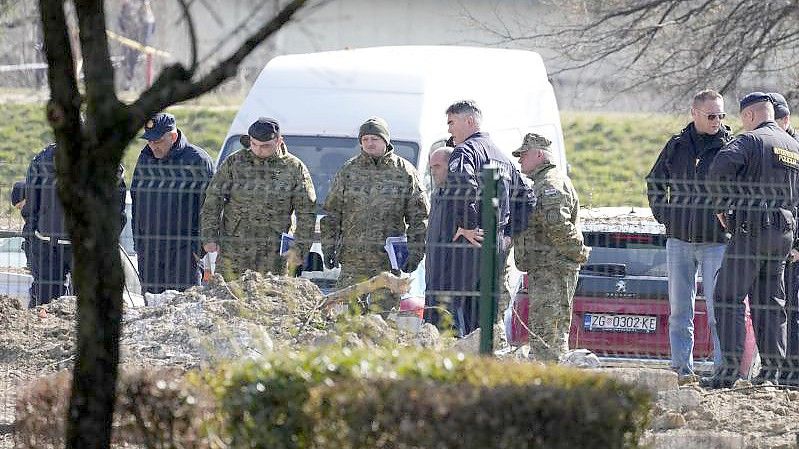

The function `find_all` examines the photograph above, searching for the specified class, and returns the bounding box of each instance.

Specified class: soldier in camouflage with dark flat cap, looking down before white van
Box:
[200,117,316,279]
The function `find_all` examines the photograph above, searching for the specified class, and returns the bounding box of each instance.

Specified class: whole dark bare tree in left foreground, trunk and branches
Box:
[36,0,319,449]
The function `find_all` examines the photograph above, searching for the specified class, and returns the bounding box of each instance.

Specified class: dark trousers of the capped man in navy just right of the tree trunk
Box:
[137,245,202,293]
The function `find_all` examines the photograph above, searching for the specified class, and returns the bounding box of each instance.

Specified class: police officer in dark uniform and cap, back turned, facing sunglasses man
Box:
[702,92,799,388]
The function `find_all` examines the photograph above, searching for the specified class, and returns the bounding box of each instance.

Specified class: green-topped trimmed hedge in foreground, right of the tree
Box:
[202,348,650,449]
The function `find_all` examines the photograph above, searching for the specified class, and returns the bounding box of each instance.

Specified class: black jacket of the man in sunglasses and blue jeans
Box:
[646,123,732,243]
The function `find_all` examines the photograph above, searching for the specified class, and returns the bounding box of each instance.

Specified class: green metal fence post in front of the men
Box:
[480,165,499,355]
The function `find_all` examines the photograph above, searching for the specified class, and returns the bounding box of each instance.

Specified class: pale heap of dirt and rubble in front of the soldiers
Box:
[0,272,442,375]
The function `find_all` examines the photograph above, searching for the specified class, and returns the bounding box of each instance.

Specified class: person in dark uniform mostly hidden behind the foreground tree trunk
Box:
[22,144,126,307]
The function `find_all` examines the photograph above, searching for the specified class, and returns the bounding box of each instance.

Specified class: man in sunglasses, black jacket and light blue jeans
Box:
[646,90,732,379]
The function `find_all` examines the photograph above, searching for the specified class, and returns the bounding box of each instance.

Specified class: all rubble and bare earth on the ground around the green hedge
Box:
[0,272,799,449]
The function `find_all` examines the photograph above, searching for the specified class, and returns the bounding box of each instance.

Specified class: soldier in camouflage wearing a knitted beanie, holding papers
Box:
[322,118,429,308]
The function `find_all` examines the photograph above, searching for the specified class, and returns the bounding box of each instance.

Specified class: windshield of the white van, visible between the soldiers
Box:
[219,135,419,203]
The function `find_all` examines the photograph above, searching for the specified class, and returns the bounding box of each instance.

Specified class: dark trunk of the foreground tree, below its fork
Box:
[59,146,124,449]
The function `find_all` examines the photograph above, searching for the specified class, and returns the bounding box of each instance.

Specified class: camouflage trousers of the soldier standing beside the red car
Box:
[527,262,580,362]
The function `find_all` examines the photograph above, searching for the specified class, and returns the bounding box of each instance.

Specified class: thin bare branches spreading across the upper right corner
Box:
[478,0,799,98]
